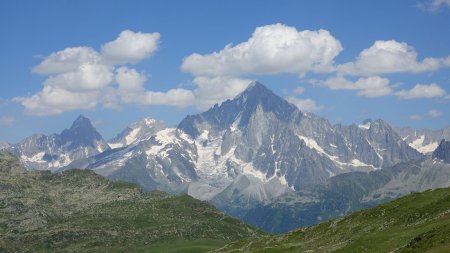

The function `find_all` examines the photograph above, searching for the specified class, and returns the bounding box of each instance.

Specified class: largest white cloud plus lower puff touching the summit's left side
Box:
[181,24,342,109]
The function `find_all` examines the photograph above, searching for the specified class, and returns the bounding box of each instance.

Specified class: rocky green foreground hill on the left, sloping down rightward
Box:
[0,153,259,252]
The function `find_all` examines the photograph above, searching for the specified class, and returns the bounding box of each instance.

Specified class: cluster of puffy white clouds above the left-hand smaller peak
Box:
[13,30,195,115]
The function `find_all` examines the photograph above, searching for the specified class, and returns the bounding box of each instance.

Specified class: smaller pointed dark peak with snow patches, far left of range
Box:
[6,115,109,170]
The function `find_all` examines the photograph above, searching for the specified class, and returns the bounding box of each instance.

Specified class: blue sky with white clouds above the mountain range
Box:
[0,0,450,143]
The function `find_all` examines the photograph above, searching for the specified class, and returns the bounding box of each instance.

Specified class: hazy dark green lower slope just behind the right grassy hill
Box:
[243,156,450,233]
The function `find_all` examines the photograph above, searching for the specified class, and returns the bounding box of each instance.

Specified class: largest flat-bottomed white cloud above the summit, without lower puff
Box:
[181,24,342,76]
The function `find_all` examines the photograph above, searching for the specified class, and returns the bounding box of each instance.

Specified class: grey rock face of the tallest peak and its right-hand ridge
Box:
[178,83,422,189]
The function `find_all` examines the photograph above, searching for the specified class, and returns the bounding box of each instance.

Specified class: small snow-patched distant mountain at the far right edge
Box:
[396,127,450,154]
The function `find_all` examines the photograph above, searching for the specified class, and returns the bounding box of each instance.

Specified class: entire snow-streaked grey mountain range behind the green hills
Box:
[3,82,450,233]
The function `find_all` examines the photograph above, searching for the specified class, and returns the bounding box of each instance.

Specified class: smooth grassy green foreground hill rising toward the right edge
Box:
[217,185,450,253]
